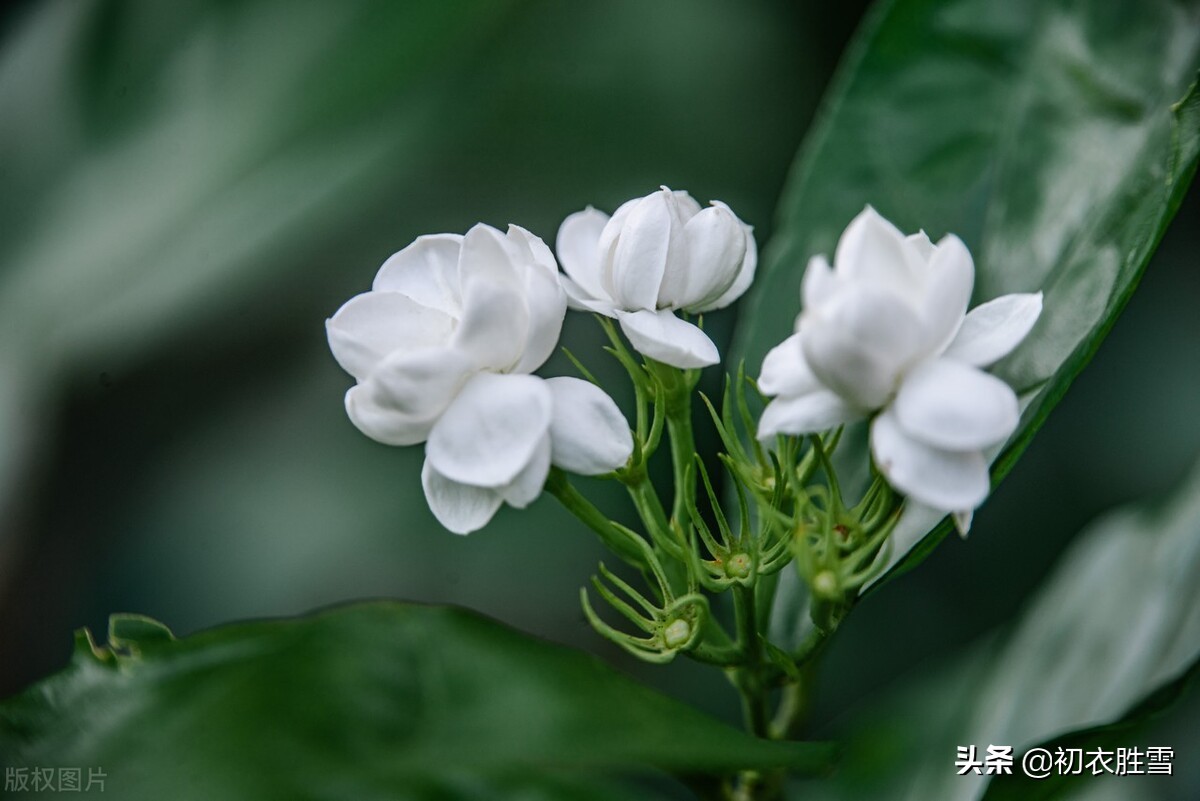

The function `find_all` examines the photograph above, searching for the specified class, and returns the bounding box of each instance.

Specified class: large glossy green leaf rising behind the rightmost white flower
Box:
[732,0,1200,578]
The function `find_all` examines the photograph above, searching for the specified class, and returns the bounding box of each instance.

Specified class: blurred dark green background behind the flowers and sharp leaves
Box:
[0,0,1200,799]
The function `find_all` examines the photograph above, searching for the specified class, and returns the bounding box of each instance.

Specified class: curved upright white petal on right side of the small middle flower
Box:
[681,203,746,309]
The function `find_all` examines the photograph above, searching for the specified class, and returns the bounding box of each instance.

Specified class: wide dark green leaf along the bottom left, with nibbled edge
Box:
[0,602,832,800]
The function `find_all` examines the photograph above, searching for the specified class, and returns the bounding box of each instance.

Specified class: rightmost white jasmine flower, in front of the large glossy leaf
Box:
[758,206,1042,526]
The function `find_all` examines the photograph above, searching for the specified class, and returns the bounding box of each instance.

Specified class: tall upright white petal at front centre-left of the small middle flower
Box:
[601,192,671,311]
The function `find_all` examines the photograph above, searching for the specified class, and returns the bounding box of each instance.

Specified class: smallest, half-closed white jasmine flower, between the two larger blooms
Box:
[557,187,758,368]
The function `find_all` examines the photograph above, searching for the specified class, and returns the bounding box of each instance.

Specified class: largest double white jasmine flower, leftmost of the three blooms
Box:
[325,224,632,534]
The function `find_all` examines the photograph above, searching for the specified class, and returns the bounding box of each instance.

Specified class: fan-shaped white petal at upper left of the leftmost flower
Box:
[372,234,462,317]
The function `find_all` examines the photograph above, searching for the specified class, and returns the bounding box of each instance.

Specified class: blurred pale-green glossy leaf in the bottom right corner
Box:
[796,455,1200,801]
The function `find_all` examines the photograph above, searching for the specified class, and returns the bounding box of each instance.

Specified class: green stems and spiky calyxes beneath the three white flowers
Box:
[547,318,901,736]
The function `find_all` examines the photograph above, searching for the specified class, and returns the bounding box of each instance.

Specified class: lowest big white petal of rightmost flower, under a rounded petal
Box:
[871,409,990,512]
